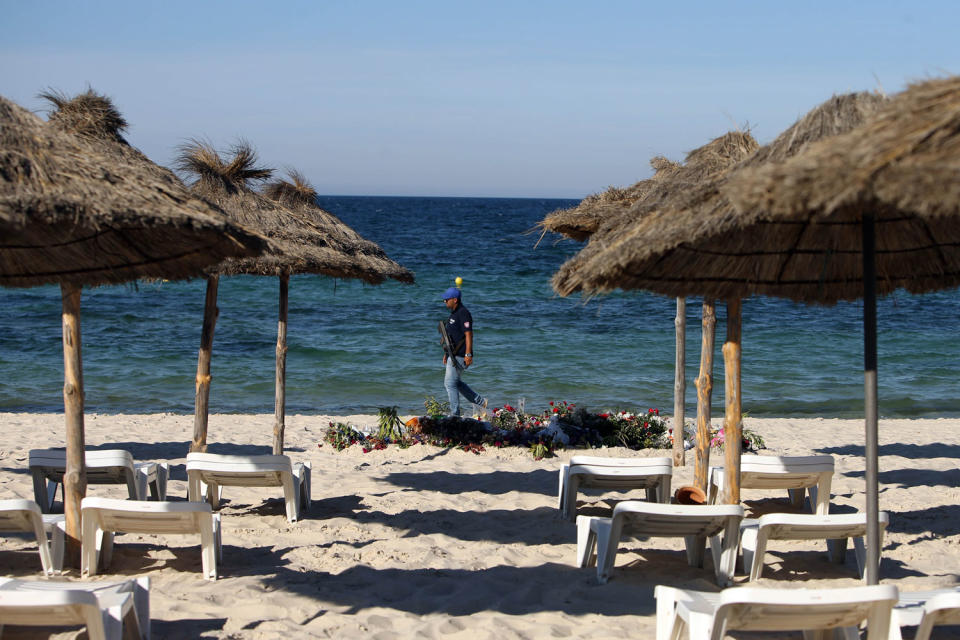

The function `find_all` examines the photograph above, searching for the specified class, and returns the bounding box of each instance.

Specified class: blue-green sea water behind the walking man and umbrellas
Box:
[0,196,960,417]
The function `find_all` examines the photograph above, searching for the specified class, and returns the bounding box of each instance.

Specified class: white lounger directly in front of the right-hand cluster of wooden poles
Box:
[577,501,743,586]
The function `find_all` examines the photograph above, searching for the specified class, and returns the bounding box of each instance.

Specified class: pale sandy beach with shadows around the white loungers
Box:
[0,413,960,640]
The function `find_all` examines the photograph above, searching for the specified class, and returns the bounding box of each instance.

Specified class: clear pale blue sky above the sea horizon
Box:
[0,0,960,198]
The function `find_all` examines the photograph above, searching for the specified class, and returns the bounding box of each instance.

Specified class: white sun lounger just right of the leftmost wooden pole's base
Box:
[80,498,222,580]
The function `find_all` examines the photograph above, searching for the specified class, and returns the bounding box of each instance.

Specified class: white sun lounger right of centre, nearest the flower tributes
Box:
[557,456,673,520]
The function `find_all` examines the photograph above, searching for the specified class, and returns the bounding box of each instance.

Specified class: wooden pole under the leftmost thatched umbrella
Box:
[60,284,87,567]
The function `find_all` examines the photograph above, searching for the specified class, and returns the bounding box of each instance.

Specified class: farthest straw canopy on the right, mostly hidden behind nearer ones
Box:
[553,131,757,296]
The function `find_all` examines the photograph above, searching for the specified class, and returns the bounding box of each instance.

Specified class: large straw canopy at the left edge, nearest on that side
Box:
[0,92,264,287]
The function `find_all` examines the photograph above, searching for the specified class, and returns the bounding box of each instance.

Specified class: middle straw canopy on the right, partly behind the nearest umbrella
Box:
[555,92,885,302]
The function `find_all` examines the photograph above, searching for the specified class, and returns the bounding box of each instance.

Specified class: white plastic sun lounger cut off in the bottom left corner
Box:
[0,577,150,640]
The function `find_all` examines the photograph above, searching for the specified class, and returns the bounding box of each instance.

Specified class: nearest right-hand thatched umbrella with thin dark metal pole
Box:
[713,76,960,584]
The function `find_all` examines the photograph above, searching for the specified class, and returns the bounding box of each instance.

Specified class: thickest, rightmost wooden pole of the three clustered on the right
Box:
[722,298,743,504]
